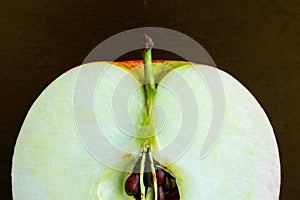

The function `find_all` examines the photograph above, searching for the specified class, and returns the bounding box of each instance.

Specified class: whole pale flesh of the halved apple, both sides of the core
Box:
[12,61,280,200]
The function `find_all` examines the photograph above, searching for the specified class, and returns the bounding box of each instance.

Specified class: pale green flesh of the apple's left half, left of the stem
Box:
[12,63,143,200]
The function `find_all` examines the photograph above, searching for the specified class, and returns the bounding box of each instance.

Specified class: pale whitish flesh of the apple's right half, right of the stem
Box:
[157,66,280,199]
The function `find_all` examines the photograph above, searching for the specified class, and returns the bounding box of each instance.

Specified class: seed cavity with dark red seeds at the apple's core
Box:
[124,148,180,200]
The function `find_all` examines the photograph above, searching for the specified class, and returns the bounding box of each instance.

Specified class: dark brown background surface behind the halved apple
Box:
[0,0,300,199]
